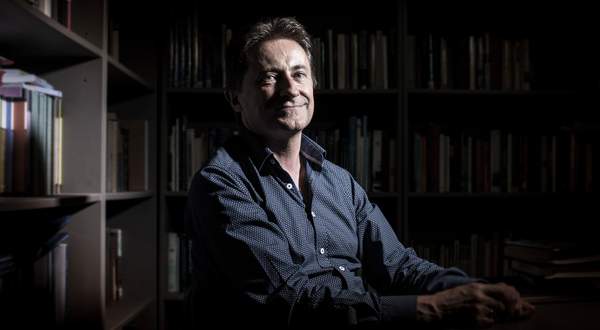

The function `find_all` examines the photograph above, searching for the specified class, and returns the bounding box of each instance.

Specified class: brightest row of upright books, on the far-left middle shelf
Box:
[0,67,63,195]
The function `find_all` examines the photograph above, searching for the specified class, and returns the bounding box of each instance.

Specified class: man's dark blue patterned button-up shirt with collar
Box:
[185,132,473,326]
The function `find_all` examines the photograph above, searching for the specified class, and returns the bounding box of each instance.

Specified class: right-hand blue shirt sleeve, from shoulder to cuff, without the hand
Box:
[352,175,477,321]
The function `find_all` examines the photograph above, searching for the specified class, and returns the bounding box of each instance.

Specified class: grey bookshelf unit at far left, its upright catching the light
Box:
[0,0,158,329]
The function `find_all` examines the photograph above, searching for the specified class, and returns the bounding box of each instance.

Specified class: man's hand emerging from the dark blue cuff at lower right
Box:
[417,283,535,327]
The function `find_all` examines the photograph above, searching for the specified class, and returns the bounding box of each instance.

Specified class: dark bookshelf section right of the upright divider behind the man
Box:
[403,2,600,290]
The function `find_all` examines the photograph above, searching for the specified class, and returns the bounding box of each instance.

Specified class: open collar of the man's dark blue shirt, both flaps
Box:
[241,129,327,171]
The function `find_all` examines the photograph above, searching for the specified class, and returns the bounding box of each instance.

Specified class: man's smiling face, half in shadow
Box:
[233,39,314,141]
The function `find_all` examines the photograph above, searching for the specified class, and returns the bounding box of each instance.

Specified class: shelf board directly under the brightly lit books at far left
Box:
[0,194,100,212]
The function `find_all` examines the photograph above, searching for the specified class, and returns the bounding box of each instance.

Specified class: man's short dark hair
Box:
[226,17,316,91]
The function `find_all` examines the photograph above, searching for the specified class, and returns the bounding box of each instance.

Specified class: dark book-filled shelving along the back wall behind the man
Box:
[159,1,600,328]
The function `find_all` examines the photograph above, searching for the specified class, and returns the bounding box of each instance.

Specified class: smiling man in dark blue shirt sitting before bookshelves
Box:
[186,18,532,327]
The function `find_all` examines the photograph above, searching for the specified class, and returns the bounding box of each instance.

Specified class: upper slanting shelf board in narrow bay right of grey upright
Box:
[108,57,153,104]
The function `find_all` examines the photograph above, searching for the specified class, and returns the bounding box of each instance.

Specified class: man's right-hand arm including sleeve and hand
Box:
[353,177,534,327]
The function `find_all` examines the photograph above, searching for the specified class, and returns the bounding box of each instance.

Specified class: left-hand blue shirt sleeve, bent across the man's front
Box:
[186,166,380,325]
